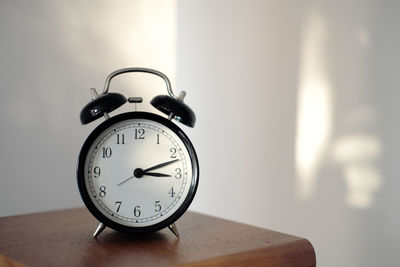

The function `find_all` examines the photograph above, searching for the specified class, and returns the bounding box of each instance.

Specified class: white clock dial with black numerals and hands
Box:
[79,114,197,228]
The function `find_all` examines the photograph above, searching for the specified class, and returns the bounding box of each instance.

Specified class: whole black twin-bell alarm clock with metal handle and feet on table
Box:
[77,68,199,237]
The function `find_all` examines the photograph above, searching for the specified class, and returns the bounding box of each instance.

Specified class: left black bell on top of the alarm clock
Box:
[80,93,127,124]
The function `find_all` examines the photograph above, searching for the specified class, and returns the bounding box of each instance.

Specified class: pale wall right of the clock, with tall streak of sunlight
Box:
[177,0,400,267]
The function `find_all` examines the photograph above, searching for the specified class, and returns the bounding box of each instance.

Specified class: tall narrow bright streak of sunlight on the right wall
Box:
[295,13,332,199]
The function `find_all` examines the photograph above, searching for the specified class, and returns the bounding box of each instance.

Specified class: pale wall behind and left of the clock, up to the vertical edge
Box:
[0,0,176,216]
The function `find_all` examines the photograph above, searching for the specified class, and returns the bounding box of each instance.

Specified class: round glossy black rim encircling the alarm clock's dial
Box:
[76,112,199,233]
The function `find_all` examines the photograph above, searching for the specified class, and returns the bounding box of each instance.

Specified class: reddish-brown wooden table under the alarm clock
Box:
[0,208,315,266]
